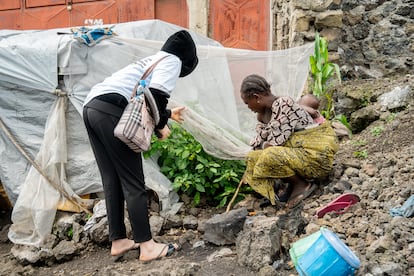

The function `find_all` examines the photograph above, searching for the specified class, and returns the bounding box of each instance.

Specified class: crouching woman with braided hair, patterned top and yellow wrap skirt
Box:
[240,75,338,208]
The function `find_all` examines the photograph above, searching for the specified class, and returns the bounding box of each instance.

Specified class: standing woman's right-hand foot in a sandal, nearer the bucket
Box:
[139,239,180,262]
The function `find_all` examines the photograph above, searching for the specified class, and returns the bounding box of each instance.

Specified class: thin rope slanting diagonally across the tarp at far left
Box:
[0,115,92,214]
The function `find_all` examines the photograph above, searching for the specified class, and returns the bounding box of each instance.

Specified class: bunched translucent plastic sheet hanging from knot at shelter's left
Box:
[8,97,67,246]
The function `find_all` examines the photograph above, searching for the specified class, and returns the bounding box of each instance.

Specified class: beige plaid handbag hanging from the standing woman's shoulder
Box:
[114,58,163,152]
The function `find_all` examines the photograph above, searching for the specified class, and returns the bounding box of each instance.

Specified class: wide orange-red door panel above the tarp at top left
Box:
[0,0,188,30]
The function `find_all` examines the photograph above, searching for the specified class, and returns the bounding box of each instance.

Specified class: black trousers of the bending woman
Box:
[83,99,152,242]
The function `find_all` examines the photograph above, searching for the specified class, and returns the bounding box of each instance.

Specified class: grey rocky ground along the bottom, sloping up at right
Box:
[0,76,414,275]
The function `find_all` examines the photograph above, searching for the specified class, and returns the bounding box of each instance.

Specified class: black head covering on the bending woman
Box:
[161,30,198,78]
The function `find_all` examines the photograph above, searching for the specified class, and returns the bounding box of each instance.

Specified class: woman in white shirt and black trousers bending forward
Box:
[83,30,198,261]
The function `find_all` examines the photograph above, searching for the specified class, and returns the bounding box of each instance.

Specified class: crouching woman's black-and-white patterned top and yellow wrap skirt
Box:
[243,97,338,204]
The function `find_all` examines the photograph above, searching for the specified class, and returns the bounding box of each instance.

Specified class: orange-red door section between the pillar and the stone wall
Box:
[209,0,270,50]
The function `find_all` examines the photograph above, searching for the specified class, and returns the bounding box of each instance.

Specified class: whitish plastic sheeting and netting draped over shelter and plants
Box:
[0,20,313,246]
